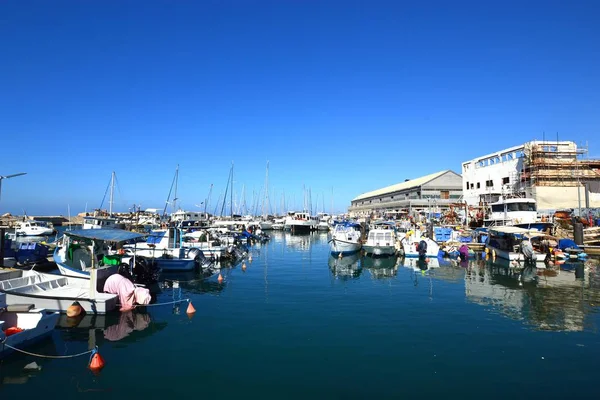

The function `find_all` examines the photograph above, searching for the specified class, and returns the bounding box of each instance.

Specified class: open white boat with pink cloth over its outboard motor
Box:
[0,270,118,314]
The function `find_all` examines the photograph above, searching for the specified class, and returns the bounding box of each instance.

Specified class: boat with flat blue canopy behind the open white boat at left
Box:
[54,229,144,280]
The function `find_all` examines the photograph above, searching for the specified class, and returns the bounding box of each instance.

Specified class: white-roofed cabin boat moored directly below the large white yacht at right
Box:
[485,226,546,262]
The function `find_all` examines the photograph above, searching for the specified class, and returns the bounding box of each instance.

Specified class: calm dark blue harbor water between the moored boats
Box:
[0,233,600,399]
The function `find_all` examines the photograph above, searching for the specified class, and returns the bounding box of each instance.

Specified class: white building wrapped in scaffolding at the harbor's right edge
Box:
[462,141,600,210]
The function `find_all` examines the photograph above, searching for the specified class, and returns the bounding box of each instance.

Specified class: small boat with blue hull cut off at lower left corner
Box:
[0,293,60,359]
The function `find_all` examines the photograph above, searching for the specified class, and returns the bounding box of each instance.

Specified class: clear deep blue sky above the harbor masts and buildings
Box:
[0,0,600,214]
